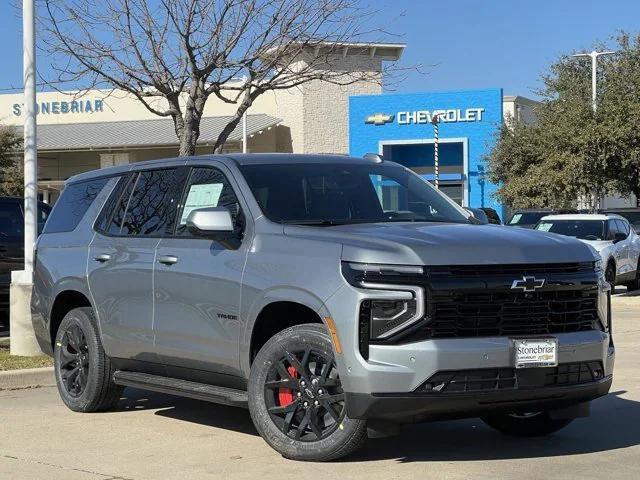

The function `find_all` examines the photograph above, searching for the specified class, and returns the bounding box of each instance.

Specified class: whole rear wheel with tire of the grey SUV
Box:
[53,307,123,412]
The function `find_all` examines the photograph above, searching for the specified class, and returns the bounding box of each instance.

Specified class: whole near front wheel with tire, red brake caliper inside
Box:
[248,324,367,461]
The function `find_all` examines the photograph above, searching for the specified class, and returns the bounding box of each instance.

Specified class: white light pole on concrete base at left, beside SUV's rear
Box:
[9,0,41,355]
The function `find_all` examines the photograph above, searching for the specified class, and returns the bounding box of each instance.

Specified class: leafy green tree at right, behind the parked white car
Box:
[487,33,640,208]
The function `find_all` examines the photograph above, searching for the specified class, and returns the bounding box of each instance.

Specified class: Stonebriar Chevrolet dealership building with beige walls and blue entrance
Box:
[0,43,535,213]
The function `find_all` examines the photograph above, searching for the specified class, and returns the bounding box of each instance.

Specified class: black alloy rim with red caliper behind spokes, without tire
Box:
[264,346,345,442]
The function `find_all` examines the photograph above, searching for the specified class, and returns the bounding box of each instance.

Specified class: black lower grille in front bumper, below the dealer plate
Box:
[415,361,604,395]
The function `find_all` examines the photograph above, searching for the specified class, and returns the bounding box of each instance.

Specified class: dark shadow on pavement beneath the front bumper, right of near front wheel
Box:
[345,391,640,462]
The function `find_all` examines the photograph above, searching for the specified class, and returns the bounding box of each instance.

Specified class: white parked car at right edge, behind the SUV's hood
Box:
[534,214,640,290]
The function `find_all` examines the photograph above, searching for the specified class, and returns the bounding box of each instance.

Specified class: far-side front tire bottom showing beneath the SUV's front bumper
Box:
[482,412,573,437]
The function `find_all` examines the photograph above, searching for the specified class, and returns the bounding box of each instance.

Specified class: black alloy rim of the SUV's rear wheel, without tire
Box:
[60,324,89,397]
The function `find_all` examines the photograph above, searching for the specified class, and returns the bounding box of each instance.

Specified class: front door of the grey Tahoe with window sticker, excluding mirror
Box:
[154,166,251,375]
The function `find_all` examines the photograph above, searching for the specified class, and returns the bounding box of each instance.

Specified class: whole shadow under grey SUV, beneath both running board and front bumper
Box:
[112,388,640,462]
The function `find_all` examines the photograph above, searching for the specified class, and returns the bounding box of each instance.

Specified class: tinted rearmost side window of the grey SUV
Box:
[44,178,109,233]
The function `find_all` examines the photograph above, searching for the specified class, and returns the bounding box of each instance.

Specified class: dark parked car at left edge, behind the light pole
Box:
[0,197,51,333]
